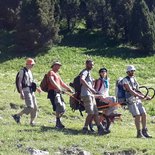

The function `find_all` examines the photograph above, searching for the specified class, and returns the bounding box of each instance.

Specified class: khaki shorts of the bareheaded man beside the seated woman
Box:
[81,96,98,115]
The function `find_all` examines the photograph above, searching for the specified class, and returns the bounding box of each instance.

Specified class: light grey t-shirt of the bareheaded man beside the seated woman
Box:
[81,70,93,96]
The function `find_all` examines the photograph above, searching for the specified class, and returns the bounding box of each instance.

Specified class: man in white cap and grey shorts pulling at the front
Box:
[123,65,152,138]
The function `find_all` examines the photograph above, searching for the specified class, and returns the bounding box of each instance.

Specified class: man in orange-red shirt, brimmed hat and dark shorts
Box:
[47,61,73,129]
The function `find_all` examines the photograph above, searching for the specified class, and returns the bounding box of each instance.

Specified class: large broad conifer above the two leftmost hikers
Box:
[16,0,58,50]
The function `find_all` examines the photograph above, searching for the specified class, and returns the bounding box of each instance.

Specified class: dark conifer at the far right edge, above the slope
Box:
[130,0,155,51]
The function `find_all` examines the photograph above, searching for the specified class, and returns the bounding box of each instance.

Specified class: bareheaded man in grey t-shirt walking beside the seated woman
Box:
[80,60,104,135]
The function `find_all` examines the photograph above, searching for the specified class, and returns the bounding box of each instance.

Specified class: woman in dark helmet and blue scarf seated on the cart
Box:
[95,68,117,117]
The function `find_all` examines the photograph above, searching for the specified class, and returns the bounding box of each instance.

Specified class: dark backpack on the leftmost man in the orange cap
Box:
[15,67,27,93]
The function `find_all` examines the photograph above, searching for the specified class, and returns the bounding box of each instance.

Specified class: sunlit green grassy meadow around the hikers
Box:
[0,30,155,155]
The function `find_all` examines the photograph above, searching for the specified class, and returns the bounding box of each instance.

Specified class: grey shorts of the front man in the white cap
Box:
[128,100,146,117]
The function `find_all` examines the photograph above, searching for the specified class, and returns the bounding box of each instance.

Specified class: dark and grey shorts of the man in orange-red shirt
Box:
[47,90,66,113]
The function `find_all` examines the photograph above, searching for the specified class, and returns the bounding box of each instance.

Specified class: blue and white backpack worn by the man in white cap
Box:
[116,76,130,104]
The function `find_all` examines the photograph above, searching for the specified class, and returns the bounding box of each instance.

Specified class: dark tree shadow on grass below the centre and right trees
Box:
[60,30,149,59]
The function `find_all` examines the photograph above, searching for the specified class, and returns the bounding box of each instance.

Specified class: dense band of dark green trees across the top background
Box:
[0,0,155,53]
